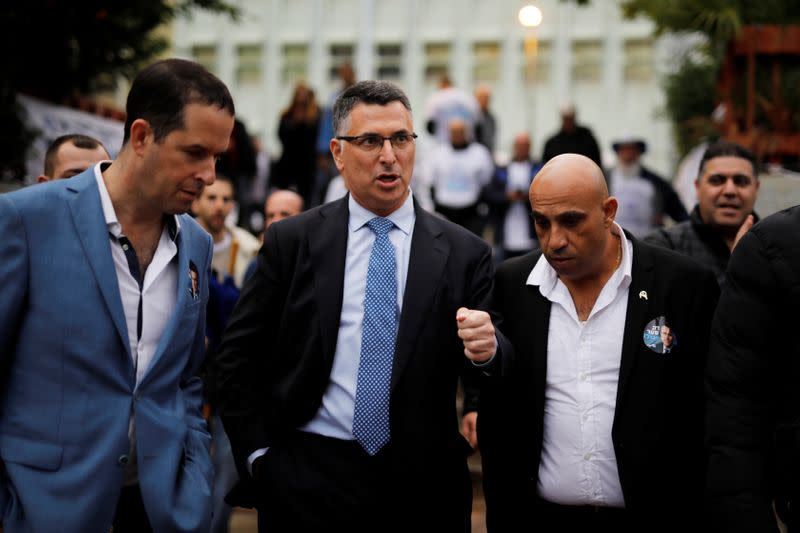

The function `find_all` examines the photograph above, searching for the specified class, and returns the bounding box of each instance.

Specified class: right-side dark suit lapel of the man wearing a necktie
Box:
[391,206,446,389]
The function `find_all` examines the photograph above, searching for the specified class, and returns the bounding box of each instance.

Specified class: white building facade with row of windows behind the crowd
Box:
[173,0,677,179]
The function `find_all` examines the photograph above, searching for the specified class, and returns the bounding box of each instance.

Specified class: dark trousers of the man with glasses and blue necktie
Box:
[255,431,471,533]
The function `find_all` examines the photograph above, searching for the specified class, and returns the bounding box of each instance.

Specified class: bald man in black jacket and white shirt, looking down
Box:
[478,154,719,533]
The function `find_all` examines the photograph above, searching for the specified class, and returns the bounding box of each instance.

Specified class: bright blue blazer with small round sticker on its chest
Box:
[0,169,213,533]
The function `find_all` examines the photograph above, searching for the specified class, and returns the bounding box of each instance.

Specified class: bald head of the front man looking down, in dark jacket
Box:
[530,154,621,287]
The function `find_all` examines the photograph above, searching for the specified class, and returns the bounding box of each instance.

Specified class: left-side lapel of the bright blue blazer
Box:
[68,172,131,361]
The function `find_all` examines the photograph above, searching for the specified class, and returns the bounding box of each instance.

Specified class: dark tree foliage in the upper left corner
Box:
[0,0,238,179]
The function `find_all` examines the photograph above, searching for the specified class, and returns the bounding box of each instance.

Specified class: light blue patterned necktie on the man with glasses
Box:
[353,218,397,455]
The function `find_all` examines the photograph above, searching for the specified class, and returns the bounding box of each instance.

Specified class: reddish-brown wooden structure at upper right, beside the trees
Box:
[717,25,800,163]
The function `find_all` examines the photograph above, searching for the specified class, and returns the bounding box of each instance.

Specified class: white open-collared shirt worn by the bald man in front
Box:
[527,223,633,507]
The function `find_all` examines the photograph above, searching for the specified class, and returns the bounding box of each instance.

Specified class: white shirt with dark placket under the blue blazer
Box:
[94,163,180,485]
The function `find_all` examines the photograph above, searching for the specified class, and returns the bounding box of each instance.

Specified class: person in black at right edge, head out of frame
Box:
[706,206,800,533]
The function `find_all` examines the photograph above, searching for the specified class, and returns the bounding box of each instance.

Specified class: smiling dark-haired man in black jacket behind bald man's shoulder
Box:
[644,142,761,285]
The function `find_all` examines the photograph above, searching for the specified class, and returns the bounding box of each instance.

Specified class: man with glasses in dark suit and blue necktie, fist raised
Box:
[212,81,497,532]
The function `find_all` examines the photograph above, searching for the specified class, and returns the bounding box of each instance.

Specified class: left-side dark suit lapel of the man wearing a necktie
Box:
[308,195,350,362]
